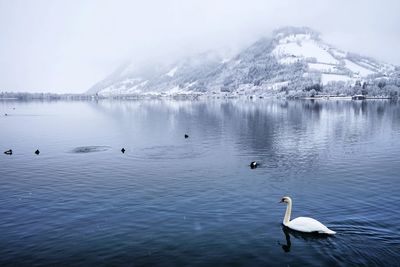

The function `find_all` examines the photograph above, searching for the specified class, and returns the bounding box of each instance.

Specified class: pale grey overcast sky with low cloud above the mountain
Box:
[0,0,400,93]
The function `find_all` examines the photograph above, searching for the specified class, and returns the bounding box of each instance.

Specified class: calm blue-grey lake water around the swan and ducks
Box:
[0,99,400,266]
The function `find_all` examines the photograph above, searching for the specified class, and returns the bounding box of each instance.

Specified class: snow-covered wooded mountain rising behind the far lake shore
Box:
[88,27,396,96]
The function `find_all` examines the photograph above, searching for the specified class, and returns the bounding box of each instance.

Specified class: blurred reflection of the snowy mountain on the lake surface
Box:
[87,99,400,171]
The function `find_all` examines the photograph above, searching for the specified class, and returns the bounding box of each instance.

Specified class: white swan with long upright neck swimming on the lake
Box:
[280,197,336,235]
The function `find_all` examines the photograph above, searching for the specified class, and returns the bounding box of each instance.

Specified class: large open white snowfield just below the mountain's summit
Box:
[272,34,339,64]
